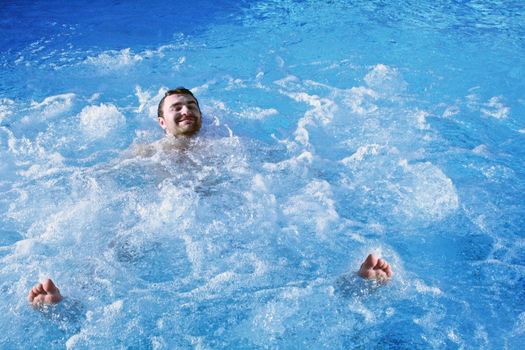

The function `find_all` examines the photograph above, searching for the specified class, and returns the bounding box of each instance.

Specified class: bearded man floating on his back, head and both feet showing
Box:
[27,87,393,306]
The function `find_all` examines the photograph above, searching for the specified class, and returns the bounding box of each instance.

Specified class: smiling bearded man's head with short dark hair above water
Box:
[157,87,202,136]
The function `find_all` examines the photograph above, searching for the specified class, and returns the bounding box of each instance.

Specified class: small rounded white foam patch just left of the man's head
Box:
[78,103,126,138]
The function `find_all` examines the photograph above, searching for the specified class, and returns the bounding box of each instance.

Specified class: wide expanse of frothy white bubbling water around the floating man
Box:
[2,65,516,348]
